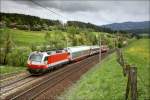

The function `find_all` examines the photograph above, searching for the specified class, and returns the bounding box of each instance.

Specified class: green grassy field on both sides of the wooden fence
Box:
[58,39,150,100]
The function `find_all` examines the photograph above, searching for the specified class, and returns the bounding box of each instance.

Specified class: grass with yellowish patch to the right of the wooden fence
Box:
[124,39,150,99]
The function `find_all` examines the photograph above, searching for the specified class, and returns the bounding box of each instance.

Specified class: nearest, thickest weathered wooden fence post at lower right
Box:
[129,67,137,100]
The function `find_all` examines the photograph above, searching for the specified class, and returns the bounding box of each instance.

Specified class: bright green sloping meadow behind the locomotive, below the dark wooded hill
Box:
[7,29,45,46]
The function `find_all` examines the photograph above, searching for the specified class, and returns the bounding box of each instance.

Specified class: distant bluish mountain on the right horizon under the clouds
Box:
[103,21,150,33]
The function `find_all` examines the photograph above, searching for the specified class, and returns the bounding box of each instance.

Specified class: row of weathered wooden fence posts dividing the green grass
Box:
[116,48,137,100]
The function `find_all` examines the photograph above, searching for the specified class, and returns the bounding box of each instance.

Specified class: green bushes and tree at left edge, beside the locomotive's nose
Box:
[0,28,31,66]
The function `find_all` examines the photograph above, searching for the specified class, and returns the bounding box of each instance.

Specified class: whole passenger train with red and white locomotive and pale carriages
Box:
[27,46,108,75]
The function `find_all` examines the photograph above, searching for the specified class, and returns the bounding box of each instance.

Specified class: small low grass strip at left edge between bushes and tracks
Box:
[0,66,26,74]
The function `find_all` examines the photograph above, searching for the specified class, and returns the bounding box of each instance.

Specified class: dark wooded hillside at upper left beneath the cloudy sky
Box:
[0,13,61,31]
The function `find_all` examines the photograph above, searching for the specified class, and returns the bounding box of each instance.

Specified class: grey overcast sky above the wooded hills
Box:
[0,0,150,25]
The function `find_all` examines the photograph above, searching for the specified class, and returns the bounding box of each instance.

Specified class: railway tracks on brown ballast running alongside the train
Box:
[1,49,113,100]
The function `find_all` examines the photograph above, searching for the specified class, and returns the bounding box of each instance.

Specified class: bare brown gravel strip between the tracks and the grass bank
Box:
[35,54,101,100]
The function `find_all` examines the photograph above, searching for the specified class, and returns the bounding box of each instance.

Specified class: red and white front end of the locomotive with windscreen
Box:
[27,52,48,74]
